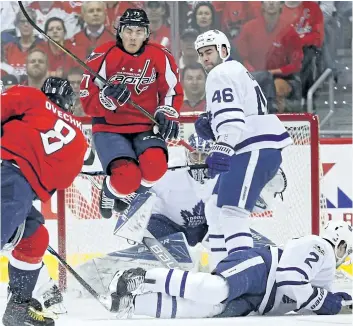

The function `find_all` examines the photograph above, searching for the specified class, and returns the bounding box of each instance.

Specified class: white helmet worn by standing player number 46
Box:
[195,29,230,62]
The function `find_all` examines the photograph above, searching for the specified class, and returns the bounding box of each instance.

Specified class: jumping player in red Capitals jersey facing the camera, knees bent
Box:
[80,9,183,218]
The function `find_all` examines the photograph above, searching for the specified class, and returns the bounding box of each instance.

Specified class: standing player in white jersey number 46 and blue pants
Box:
[190,30,292,266]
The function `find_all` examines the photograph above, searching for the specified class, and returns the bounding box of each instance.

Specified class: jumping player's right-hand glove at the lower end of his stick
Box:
[153,105,179,140]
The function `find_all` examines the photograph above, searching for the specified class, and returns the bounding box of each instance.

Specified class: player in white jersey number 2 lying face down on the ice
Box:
[110,221,352,318]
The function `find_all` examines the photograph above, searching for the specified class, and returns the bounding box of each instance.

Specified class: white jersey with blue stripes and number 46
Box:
[206,60,292,154]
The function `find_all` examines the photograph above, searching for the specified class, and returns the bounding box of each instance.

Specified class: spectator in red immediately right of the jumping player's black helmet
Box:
[145,1,171,47]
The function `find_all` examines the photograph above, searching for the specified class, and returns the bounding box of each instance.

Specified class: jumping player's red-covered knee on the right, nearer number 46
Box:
[139,147,168,183]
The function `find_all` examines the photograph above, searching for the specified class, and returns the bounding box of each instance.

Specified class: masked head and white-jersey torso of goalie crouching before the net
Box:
[147,134,217,246]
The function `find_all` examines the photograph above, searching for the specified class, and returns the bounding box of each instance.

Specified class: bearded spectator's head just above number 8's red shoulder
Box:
[23,48,48,89]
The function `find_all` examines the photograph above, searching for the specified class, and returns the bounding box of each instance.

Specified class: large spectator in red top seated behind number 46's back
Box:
[236,1,303,113]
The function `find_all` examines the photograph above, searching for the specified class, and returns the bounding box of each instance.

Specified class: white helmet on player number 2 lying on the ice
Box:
[320,221,353,267]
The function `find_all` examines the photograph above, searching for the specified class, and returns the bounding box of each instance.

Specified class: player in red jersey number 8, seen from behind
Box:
[0,77,87,326]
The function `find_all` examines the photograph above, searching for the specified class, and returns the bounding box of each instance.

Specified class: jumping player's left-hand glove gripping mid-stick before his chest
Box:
[99,84,131,111]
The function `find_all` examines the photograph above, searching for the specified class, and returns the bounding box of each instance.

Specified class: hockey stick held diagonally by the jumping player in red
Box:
[18,1,159,126]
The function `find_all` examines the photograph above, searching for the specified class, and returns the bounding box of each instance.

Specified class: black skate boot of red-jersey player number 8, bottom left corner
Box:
[2,296,55,326]
